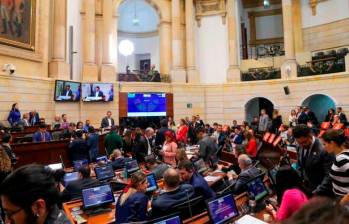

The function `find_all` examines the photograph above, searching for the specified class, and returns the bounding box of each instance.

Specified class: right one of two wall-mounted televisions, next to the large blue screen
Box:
[81,83,114,102]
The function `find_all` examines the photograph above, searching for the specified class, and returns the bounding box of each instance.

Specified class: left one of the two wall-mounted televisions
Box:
[54,80,81,102]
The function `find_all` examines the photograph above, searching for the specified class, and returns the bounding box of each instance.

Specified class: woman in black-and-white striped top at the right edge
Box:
[322,129,349,205]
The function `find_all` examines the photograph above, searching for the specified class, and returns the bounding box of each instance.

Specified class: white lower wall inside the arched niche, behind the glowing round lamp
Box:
[116,36,160,73]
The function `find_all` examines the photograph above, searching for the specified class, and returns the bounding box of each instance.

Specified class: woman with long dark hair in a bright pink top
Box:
[267,166,308,221]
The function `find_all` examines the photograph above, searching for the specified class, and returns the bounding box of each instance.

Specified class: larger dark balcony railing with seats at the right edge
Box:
[298,48,349,77]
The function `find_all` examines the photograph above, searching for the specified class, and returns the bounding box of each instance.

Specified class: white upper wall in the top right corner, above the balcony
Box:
[302,0,349,28]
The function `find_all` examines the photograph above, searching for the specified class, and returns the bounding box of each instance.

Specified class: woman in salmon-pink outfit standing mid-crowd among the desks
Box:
[160,131,177,167]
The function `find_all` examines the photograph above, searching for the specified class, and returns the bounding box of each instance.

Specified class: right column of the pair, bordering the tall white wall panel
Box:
[185,0,200,83]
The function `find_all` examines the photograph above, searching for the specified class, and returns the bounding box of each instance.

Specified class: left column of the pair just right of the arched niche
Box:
[171,0,186,82]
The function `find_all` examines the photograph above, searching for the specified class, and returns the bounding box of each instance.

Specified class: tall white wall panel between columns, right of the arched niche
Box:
[195,16,228,83]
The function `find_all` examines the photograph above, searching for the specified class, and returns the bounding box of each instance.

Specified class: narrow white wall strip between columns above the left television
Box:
[66,0,82,81]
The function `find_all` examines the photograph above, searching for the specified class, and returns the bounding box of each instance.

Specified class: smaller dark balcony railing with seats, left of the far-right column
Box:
[241,67,281,82]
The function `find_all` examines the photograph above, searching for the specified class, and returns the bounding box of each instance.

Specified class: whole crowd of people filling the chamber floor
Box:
[0,105,349,224]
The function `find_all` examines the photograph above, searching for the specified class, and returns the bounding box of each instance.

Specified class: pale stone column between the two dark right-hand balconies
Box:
[281,0,297,79]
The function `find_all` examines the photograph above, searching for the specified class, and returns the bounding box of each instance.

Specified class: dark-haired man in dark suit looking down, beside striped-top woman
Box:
[293,124,334,195]
